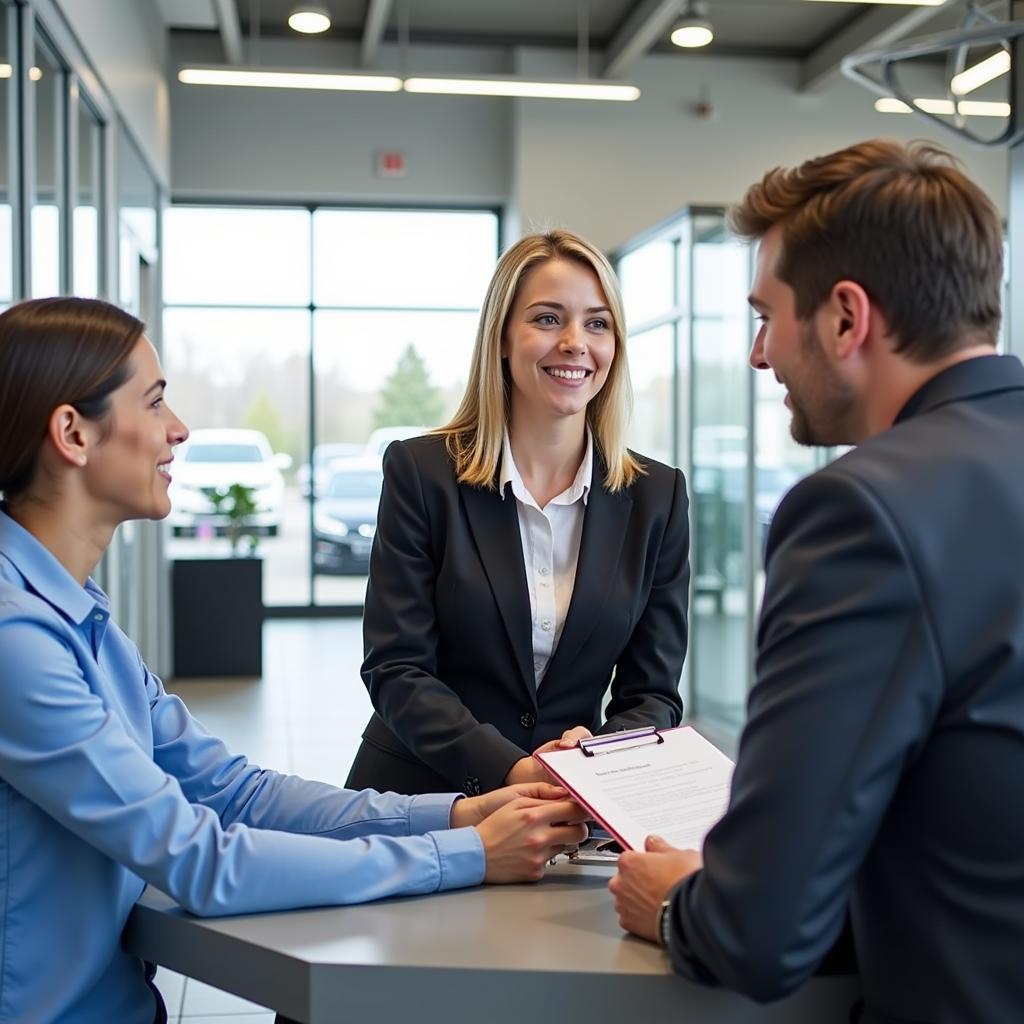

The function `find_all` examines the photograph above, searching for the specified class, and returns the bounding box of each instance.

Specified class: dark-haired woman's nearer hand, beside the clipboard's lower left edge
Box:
[476,786,587,882]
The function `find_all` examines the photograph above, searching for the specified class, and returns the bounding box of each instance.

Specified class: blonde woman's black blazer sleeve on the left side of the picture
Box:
[362,442,528,791]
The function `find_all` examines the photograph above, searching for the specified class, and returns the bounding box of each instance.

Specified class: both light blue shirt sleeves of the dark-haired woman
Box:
[0,616,483,915]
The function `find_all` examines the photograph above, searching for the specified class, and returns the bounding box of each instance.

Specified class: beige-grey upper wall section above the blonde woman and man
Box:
[514,51,1008,249]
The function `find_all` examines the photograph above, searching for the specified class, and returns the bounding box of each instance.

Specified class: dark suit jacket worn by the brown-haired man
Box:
[672,355,1024,1024]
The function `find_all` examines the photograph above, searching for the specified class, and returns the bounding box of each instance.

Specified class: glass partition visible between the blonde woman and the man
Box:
[616,208,818,744]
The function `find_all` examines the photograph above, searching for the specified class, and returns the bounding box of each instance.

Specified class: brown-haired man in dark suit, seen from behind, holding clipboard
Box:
[611,141,1024,1024]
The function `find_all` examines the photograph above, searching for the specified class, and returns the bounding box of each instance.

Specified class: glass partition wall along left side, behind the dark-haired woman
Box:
[0,0,169,673]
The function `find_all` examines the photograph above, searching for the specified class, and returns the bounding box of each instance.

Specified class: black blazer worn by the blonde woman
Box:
[348,436,689,794]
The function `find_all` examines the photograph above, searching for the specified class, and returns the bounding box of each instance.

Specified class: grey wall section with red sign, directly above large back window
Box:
[171,36,513,205]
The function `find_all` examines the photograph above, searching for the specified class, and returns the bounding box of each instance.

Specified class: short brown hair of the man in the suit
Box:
[729,139,1002,362]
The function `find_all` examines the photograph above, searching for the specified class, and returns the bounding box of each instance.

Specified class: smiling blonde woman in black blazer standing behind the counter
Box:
[347,231,689,794]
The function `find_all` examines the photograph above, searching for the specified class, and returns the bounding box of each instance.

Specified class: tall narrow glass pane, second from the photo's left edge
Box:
[29,36,68,297]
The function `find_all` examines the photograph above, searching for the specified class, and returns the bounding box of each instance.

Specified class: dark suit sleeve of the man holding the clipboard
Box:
[671,465,944,999]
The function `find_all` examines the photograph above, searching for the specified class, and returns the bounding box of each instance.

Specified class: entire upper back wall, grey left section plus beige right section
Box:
[165,37,1007,256]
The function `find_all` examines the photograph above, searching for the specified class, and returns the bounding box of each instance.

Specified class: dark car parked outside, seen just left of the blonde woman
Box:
[313,457,384,574]
